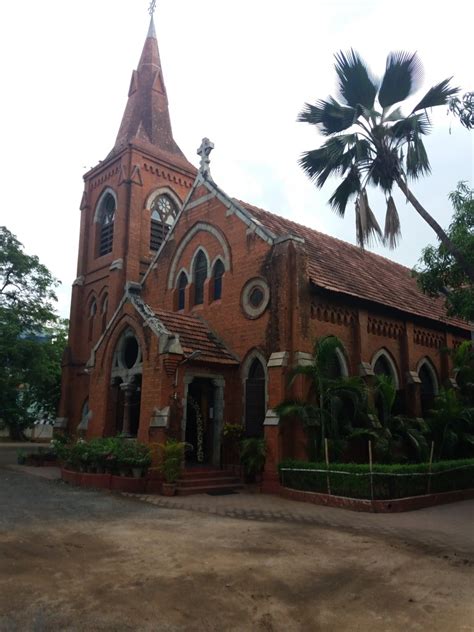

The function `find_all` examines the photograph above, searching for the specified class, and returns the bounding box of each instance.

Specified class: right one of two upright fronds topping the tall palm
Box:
[378,51,423,108]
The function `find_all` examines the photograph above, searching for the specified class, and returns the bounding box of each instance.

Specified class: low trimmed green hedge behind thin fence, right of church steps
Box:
[279,459,474,500]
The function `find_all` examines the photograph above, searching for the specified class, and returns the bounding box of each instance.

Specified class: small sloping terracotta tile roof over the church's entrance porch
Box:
[153,309,239,364]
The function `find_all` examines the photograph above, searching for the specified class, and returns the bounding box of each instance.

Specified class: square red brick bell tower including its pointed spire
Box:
[59,9,196,429]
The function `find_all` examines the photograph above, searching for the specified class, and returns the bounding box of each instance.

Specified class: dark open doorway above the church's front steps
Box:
[183,375,224,468]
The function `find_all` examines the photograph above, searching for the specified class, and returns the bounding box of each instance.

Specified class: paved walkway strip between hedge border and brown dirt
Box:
[125,492,474,561]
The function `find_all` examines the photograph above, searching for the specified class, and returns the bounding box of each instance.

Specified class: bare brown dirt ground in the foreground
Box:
[0,469,474,632]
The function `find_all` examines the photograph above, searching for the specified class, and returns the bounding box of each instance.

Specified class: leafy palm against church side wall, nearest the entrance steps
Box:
[276,335,365,458]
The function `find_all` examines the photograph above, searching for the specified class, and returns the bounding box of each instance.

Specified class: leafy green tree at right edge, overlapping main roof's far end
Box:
[415,182,474,321]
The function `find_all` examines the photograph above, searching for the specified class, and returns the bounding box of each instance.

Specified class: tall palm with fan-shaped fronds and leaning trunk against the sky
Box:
[298,50,474,281]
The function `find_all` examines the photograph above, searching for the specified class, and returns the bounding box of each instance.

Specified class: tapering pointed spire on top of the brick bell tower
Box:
[109,14,187,163]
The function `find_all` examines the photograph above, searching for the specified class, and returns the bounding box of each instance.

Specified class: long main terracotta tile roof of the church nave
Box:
[238,200,471,330]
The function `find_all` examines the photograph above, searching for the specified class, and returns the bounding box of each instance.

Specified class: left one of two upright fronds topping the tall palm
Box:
[335,49,377,109]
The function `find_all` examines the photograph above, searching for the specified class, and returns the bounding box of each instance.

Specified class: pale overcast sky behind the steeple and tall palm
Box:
[0,0,474,316]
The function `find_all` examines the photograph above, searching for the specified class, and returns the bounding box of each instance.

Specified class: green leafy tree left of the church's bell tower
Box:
[0,226,66,438]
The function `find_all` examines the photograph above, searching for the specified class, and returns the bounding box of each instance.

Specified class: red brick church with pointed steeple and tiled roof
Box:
[57,13,470,489]
